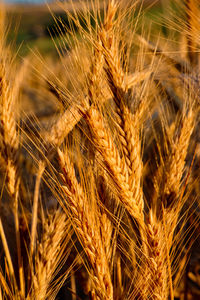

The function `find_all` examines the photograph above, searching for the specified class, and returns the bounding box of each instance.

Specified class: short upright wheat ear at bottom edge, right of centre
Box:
[133,209,169,300]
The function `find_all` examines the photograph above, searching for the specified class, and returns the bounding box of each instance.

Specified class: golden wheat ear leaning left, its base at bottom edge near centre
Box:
[58,149,113,300]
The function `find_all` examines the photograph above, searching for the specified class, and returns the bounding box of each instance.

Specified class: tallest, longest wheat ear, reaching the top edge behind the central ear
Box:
[100,1,144,213]
